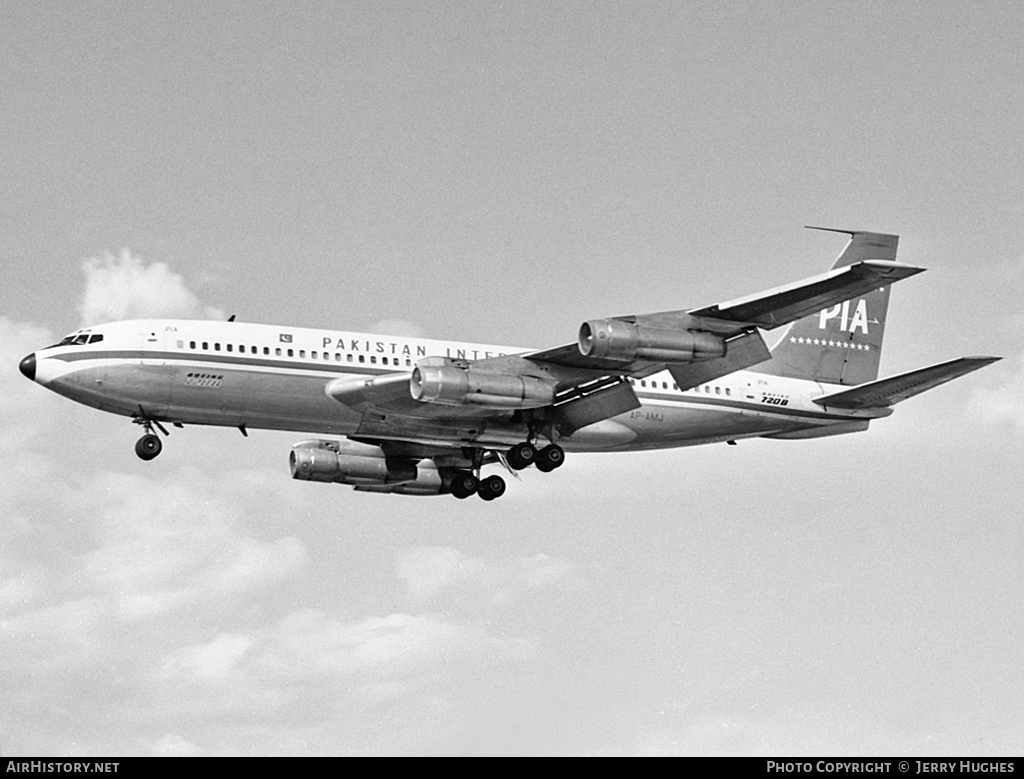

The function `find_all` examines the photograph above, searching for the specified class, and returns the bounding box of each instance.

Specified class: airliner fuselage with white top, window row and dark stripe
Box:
[25,319,887,451]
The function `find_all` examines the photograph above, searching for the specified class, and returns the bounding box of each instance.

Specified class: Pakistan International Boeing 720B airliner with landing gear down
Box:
[20,230,999,501]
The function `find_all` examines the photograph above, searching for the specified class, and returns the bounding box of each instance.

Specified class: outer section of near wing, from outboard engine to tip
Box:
[688,260,925,330]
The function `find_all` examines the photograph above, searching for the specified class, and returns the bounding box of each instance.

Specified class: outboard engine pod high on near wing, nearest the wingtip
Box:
[580,319,725,362]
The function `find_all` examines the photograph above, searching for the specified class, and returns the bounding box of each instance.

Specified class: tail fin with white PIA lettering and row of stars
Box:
[750,227,899,385]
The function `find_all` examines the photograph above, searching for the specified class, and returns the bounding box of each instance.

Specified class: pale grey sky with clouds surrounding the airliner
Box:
[0,2,1024,755]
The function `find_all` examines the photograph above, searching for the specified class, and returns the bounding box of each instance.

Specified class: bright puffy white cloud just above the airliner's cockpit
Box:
[81,249,224,324]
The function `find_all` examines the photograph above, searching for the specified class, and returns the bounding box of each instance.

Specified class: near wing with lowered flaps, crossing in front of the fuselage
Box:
[326,260,924,435]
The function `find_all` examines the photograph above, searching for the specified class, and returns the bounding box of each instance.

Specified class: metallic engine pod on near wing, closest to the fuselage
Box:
[409,357,557,408]
